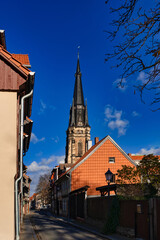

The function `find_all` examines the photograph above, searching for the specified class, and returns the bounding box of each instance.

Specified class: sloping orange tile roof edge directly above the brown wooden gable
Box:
[0,45,31,75]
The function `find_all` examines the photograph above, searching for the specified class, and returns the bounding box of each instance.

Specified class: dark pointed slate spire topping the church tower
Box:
[73,54,84,106]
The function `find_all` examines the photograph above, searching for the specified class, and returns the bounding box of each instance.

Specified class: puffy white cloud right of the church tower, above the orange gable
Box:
[105,105,129,136]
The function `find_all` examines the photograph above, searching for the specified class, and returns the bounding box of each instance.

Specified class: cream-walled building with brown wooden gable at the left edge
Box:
[0,30,34,240]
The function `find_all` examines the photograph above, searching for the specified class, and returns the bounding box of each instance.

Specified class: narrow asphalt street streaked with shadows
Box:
[26,210,106,240]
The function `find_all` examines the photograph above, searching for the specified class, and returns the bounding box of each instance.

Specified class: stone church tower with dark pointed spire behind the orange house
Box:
[65,54,91,164]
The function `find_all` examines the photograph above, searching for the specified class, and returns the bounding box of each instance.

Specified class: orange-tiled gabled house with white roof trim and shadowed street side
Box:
[53,136,136,218]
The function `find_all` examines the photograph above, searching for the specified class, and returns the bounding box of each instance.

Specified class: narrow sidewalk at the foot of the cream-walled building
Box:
[20,214,38,240]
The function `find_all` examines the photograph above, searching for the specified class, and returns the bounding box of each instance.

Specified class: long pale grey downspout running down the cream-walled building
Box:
[15,72,34,240]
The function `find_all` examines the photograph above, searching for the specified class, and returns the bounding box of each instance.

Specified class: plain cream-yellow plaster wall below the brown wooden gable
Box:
[0,92,17,240]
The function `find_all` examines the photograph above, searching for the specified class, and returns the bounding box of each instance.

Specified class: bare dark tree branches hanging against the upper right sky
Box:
[105,0,160,110]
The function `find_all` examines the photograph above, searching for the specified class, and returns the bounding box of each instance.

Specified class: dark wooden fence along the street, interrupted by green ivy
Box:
[87,197,160,240]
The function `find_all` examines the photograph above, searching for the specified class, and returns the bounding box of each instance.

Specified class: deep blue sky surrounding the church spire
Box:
[0,0,160,193]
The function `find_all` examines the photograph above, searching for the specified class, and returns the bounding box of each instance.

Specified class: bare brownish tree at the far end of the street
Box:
[36,173,51,204]
